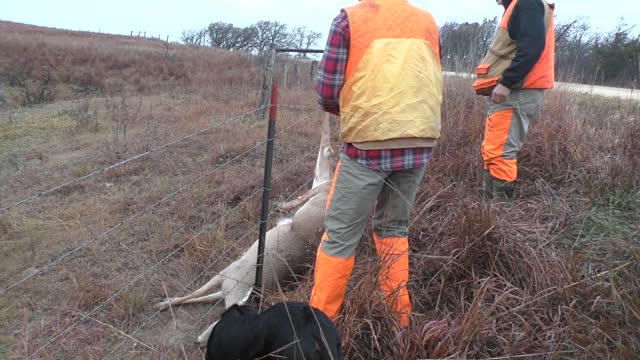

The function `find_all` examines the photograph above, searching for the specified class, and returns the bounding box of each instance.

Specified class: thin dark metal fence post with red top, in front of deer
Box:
[254,83,278,297]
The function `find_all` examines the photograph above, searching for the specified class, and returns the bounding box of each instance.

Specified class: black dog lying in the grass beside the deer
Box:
[205,302,341,360]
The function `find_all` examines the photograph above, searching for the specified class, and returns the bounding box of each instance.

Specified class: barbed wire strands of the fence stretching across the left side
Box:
[0,44,319,359]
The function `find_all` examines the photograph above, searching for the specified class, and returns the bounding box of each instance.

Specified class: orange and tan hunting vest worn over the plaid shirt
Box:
[340,0,442,143]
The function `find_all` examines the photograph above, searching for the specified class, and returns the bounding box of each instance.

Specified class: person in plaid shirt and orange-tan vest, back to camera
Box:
[310,0,442,327]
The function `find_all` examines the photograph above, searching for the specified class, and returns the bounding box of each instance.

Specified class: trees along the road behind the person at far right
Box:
[440,18,640,88]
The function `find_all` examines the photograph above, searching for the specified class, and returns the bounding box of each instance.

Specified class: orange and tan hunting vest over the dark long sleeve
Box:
[473,0,556,95]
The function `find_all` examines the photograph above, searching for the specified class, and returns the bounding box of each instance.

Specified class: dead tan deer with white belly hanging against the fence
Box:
[156,114,333,346]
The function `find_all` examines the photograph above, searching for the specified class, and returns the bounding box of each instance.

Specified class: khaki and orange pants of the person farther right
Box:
[481,89,544,181]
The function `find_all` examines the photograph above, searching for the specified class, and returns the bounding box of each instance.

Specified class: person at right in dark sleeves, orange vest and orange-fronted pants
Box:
[473,0,555,201]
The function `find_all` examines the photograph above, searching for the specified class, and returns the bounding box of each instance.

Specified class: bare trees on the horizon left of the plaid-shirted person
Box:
[181,21,322,53]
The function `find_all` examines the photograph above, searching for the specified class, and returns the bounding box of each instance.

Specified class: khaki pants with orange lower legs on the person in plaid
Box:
[311,154,426,327]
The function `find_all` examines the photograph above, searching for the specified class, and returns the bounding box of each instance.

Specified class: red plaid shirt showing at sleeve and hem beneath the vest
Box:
[316,11,432,171]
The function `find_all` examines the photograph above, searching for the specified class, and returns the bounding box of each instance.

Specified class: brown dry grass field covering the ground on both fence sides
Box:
[0,22,640,360]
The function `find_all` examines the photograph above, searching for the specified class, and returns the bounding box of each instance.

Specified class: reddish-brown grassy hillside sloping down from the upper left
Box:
[0,22,256,105]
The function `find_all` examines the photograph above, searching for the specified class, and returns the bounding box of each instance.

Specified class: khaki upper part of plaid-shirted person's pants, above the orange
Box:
[321,153,426,258]
